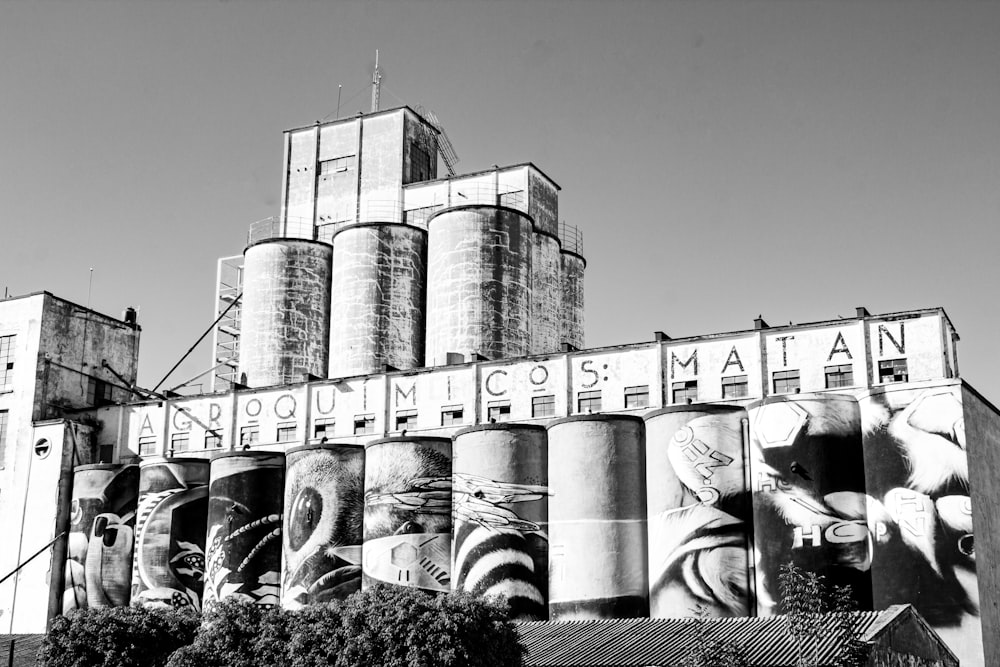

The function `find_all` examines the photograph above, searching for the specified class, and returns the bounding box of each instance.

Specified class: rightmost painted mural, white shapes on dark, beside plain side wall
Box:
[860,386,982,665]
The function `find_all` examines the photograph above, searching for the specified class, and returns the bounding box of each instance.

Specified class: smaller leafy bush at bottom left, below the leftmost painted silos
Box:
[39,607,199,667]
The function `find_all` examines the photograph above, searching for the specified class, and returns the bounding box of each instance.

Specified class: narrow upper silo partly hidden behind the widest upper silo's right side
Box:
[529,230,562,354]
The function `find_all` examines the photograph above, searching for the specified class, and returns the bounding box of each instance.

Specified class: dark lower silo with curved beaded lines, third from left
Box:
[205,451,285,607]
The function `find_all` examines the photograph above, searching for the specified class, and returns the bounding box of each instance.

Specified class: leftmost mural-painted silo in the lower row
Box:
[63,463,139,614]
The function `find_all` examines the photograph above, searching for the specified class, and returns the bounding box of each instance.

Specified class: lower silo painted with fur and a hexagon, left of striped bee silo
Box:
[362,437,451,592]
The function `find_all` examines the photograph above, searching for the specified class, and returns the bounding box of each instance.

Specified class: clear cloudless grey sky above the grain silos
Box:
[0,0,1000,402]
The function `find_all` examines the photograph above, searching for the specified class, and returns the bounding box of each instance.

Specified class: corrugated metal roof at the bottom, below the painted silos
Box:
[518,606,906,667]
